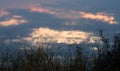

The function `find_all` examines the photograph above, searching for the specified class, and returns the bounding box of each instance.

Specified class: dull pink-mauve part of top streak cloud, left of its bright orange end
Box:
[30,6,81,19]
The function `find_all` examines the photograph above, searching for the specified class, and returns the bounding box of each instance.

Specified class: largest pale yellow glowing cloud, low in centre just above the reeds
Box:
[24,28,99,44]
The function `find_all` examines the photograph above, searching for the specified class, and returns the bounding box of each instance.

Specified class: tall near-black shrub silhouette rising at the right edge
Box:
[93,32,120,71]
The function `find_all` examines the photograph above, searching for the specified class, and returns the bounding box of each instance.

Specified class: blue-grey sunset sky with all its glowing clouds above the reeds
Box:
[0,0,120,45]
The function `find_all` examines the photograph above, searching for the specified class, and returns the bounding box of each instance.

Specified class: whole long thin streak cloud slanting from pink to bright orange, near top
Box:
[30,6,119,24]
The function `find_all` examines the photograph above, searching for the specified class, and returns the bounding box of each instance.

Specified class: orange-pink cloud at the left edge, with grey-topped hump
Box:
[0,15,27,27]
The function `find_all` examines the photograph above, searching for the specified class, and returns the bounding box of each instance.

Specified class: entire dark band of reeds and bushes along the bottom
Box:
[0,31,120,71]
